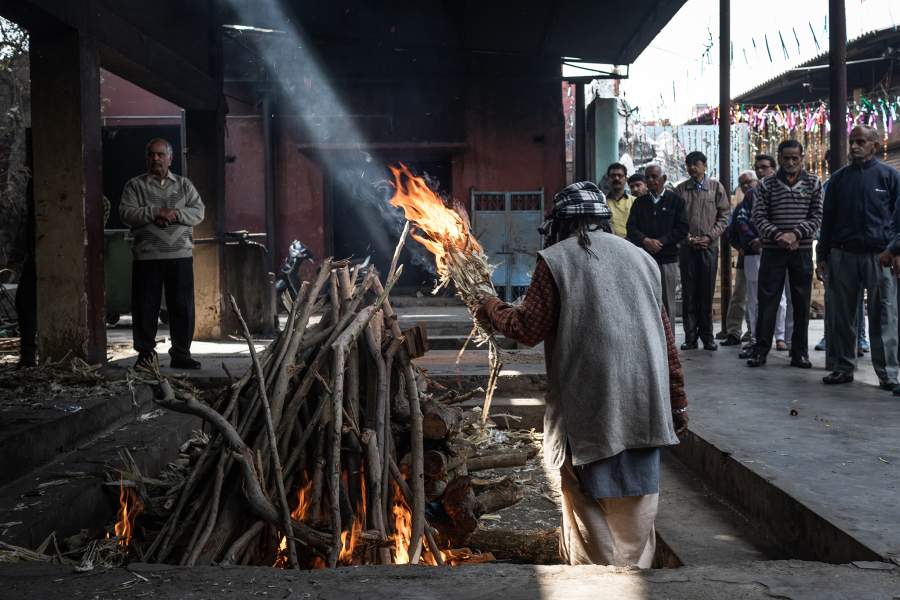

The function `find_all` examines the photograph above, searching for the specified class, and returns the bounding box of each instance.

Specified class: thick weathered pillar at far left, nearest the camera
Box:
[30,28,106,363]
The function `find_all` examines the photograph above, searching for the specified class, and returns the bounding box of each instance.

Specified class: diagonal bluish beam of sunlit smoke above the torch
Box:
[221,0,435,274]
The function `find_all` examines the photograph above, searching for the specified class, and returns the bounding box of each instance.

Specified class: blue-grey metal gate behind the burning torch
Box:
[471,190,544,302]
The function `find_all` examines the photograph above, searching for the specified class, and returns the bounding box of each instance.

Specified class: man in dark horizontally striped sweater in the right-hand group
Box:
[747,140,822,369]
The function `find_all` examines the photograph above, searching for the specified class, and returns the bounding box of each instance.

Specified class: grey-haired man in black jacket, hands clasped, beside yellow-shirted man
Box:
[628,165,689,323]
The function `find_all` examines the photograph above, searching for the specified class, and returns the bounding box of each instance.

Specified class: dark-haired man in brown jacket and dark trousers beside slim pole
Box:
[675,152,731,350]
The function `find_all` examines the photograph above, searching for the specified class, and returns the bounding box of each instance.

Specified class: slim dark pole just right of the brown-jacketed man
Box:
[719,0,731,331]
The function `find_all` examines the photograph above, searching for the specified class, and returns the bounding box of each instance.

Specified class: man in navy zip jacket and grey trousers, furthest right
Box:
[816,125,900,390]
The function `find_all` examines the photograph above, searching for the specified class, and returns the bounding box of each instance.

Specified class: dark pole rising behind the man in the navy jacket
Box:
[828,0,847,173]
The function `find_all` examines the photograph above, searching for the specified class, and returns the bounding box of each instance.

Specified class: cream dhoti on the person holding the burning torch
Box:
[560,460,659,569]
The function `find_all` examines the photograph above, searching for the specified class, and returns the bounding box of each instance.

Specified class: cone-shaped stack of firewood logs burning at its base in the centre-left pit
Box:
[124,260,524,568]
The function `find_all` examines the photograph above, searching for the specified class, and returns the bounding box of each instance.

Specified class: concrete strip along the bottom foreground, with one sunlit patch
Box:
[0,561,900,600]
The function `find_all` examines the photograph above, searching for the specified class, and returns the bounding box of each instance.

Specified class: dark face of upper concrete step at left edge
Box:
[0,385,152,486]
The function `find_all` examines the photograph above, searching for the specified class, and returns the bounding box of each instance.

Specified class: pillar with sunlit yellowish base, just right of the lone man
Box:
[185,109,227,339]
